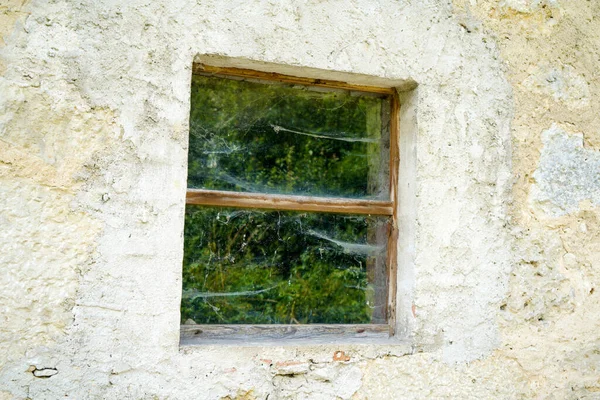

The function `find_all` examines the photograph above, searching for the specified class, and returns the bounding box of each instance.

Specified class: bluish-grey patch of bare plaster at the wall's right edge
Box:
[531,125,600,217]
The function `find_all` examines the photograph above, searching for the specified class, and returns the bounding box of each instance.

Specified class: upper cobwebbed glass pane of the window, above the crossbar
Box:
[188,75,390,200]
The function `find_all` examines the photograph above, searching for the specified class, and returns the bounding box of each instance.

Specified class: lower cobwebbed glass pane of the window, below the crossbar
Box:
[181,205,389,324]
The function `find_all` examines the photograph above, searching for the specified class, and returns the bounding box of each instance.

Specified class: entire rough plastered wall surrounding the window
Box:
[0,0,600,400]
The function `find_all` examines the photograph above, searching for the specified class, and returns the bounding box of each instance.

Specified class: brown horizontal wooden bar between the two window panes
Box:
[186,189,394,215]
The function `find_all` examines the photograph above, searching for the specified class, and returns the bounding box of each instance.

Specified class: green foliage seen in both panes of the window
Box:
[181,76,389,324]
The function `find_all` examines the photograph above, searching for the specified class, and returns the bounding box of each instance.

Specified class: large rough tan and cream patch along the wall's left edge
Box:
[0,50,118,373]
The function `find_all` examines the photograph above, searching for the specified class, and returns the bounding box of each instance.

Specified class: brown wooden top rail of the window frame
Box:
[193,64,396,95]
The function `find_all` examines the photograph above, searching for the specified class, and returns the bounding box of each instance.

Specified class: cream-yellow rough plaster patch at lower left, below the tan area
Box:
[0,180,99,367]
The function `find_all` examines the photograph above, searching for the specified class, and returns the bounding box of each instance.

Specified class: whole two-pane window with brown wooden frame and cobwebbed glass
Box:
[181,64,398,343]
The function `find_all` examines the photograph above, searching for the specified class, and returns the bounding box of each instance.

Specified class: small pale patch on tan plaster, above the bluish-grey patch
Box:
[523,65,590,109]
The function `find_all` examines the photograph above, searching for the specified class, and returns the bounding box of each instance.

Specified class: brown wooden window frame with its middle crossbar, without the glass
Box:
[180,63,400,345]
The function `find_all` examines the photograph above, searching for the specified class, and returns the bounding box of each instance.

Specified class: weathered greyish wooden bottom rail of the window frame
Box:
[181,324,389,344]
